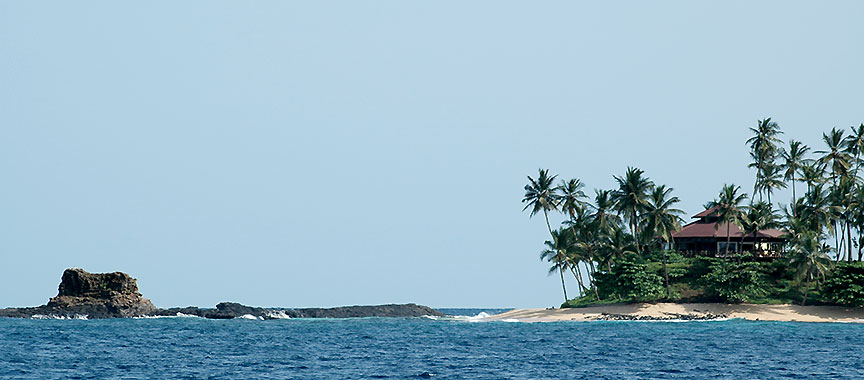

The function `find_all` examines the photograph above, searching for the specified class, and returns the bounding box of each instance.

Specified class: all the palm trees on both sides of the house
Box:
[522,118,864,299]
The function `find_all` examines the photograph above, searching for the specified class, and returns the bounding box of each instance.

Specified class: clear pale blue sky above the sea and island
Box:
[0,1,864,307]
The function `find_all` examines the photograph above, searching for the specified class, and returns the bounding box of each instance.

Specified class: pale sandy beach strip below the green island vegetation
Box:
[488,303,864,323]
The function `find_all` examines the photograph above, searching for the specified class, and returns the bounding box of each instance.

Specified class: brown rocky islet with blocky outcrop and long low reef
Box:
[0,268,445,319]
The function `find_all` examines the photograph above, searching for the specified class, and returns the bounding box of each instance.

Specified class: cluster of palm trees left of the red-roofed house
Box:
[522,168,683,302]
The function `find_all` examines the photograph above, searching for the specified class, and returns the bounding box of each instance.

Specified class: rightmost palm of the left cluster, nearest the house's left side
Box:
[645,185,684,299]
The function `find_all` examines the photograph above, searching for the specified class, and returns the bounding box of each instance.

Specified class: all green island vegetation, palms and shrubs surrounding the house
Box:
[522,118,864,306]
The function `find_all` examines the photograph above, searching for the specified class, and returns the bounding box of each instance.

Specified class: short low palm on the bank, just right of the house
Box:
[789,232,831,305]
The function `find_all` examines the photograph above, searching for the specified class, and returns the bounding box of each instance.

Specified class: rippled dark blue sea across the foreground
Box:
[0,309,864,379]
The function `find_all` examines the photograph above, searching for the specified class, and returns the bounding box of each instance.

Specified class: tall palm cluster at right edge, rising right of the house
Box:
[747,118,864,261]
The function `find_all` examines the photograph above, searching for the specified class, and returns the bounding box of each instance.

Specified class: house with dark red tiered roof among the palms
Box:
[672,207,788,257]
